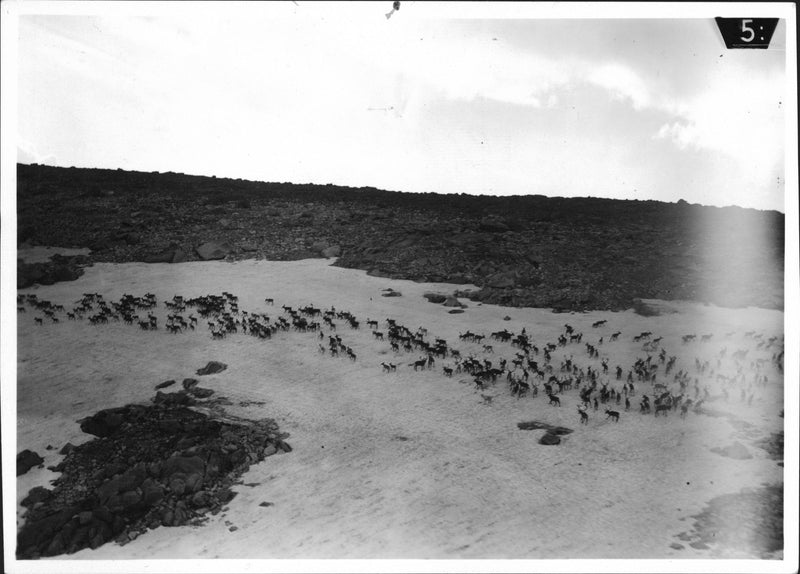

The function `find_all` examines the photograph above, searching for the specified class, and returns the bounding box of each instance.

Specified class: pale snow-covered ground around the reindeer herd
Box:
[7,255,784,564]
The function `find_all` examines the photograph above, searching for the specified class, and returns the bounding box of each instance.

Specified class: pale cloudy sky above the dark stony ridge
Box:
[12,2,788,211]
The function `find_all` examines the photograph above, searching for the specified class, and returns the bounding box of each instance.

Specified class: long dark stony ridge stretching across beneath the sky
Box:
[17,165,785,310]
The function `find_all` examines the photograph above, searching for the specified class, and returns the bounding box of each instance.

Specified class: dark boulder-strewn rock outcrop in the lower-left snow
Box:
[17,391,291,559]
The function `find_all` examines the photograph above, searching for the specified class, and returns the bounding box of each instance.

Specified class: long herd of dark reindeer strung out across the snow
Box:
[17,292,783,432]
